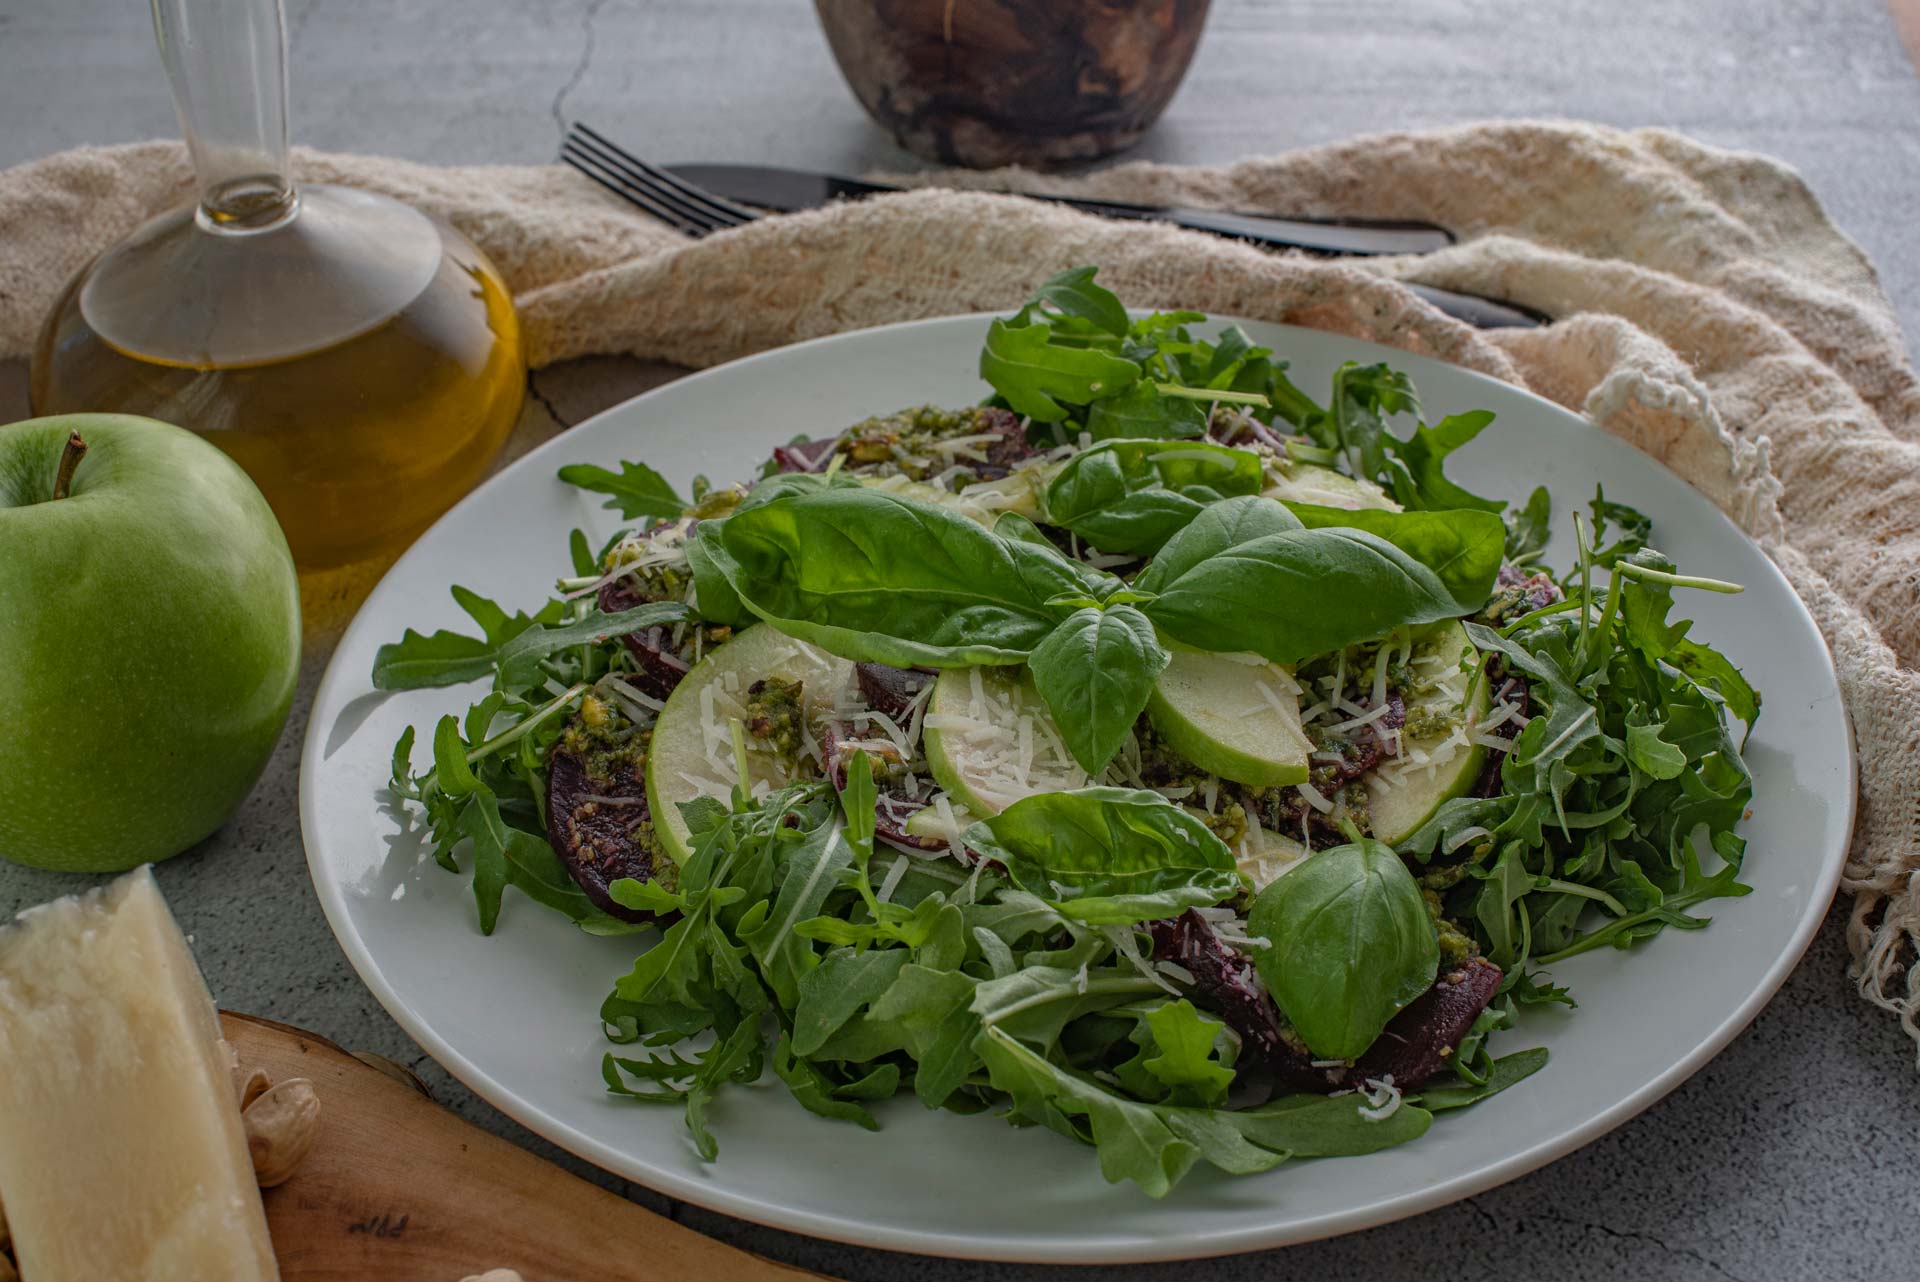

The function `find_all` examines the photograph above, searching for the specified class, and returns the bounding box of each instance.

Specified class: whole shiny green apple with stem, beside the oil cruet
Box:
[0,415,300,873]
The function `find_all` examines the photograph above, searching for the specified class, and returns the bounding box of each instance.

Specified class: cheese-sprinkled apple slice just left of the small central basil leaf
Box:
[920,668,1087,818]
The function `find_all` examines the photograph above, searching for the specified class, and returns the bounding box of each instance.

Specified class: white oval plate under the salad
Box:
[300,317,1853,1263]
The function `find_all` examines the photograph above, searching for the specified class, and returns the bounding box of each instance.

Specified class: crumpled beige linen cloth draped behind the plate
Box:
[0,125,1920,1040]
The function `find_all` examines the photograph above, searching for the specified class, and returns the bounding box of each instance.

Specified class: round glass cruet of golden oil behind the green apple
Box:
[31,0,526,628]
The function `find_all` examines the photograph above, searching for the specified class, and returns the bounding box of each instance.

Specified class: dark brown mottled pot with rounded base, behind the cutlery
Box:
[814,0,1208,169]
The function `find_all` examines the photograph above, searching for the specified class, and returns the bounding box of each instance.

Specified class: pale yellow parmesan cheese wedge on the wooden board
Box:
[0,867,280,1282]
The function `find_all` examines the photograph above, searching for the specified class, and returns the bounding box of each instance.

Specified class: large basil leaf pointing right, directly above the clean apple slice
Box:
[1142,528,1480,664]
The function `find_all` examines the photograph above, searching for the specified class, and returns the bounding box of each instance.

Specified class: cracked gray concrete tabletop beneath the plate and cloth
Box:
[0,0,1920,1282]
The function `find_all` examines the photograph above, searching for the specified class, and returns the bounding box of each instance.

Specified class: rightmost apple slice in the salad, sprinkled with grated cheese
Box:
[1367,622,1490,846]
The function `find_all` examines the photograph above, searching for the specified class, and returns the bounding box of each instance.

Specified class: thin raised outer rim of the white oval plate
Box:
[300,313,1859,1265]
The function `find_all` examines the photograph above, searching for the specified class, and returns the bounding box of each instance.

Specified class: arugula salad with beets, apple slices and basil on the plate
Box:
[374,269,1759,1196]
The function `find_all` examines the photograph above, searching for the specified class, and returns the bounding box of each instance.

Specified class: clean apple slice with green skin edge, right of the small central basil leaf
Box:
[1146,649,1313,787]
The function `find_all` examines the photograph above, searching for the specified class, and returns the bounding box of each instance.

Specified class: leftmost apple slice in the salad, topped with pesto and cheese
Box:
[647,624,852,864]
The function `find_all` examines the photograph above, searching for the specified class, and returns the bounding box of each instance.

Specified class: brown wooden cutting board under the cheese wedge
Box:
[221,1011,824,1282]
